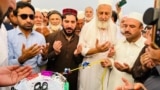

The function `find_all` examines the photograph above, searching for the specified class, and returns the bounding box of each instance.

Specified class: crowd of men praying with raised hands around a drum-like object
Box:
[0,0,160,90]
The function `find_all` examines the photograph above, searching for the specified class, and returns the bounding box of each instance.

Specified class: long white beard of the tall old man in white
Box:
[96,19,109,30]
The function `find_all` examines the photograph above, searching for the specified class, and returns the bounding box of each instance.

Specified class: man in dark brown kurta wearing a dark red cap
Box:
[47,8,82,90]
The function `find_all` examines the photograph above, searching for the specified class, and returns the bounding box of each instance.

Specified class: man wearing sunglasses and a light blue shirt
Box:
[8,1,49,73]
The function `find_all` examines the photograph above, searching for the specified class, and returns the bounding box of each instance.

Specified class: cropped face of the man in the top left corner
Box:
[0,0,16,24]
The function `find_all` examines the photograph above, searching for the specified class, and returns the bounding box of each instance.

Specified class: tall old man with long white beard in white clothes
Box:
[78,0,116,90]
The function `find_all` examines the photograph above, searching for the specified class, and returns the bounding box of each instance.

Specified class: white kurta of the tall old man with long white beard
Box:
[78,18,116,90]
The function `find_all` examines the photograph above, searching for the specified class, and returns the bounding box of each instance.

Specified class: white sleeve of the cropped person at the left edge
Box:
[0,24,10,90]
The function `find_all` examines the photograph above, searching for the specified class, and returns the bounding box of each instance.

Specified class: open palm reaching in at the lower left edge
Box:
[0,65,32,86]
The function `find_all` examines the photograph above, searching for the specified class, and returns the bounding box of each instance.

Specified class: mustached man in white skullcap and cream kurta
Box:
[103,12,146,90]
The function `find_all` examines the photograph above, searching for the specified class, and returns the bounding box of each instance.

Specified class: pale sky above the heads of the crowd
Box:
[19,0,154,15]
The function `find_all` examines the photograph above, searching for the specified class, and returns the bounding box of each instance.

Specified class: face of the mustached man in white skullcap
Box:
[123,18,143,42]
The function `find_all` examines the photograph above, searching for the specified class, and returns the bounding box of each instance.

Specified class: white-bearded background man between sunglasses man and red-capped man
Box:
[48,10,62,33]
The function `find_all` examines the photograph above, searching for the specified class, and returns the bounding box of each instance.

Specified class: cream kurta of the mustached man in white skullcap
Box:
[108,37,146,90]
